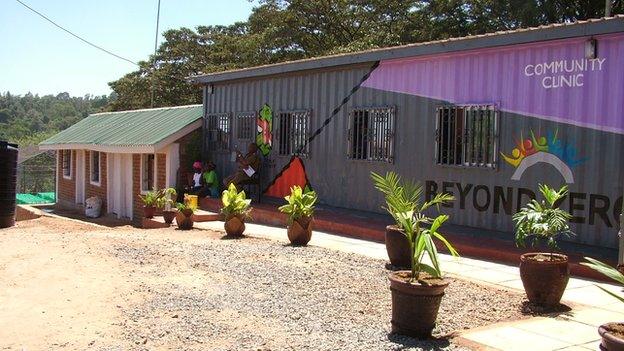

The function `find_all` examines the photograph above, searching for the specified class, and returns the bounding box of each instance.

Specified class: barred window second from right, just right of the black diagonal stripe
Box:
[348,107,395,163]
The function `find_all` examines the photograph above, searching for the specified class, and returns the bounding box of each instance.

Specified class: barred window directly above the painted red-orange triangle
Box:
[277,110,310,157]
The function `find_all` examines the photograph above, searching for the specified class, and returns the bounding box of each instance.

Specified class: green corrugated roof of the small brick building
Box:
[39,105,202,146]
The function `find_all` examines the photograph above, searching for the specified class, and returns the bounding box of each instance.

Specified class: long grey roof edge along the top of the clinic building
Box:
[187,15,624,84]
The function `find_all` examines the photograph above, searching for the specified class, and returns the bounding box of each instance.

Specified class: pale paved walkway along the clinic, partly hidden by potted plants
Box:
[195,221,624,351]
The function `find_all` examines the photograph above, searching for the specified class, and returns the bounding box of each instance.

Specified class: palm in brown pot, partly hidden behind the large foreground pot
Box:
[371,172,422,268]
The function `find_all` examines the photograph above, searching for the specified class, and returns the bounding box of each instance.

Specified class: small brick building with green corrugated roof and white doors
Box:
[39,105,203,223]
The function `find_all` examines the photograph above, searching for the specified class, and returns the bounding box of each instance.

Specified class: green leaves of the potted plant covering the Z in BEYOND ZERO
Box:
[513,184,572,261]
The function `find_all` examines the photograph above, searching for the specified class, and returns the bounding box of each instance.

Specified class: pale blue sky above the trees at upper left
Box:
[0,0,256,96]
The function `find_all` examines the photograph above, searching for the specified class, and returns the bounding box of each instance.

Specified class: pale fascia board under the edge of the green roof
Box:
[39,118,202,154]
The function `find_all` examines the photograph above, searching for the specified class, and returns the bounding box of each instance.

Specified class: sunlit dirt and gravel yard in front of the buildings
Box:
[0,217,536,350]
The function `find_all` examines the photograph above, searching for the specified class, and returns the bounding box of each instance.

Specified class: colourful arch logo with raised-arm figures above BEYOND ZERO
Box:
[501,130,586,184]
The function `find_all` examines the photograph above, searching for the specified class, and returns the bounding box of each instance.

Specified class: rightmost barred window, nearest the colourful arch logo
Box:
[435,105,498,168]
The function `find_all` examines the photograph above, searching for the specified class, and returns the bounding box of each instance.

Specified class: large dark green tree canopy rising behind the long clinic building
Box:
[109,0,624,110]
